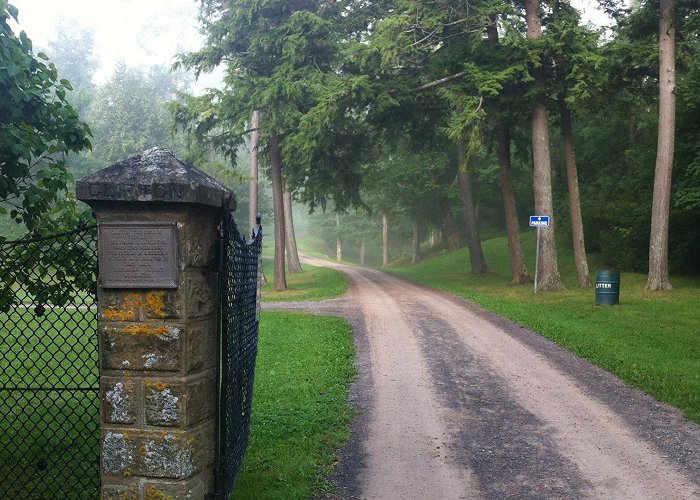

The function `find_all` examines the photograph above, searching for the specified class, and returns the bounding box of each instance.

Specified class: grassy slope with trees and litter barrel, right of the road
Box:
[387,232,700,423]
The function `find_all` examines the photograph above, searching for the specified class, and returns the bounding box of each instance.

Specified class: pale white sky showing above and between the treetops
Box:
[10,0,608,88]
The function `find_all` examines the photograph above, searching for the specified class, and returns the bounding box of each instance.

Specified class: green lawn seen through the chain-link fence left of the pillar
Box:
[0,308,100,498]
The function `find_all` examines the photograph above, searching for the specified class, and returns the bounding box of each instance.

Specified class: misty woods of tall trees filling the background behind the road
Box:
[0,0,700,290]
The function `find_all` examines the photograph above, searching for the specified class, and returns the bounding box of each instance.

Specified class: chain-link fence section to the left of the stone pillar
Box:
[0,226,100,499]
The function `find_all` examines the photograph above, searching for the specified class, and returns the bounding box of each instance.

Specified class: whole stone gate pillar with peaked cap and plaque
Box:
[77,149,235,500]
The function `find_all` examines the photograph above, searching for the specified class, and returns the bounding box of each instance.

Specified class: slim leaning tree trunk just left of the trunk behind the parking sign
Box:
[486,20,531,285]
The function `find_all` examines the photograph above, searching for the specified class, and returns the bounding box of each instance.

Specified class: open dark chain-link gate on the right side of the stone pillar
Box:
[215,209,262,498]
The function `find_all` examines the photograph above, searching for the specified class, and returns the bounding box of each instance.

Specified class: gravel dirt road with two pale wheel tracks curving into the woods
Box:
[266,262,700,499]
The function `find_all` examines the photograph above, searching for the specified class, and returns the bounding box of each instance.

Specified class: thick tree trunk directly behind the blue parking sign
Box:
[525,0,564,291]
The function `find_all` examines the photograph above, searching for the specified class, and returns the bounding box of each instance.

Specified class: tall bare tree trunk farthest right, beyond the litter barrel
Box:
[646,0,676,290]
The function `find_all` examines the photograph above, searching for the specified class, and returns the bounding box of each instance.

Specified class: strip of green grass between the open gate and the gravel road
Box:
[232,312,355,499]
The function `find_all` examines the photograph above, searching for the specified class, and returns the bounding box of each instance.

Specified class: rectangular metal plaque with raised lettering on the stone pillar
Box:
[97,222,178,288]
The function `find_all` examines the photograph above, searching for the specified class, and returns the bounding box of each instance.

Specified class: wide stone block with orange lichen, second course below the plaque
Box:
[99,322,184,371]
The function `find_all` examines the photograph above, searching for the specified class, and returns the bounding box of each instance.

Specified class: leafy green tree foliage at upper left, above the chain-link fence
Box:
[0,1,91,238]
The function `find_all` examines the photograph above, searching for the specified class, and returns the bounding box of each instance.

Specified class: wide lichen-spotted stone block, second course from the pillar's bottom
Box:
[102,423,215,479]
